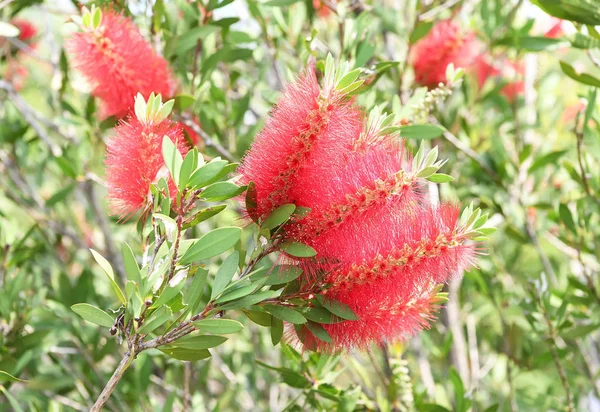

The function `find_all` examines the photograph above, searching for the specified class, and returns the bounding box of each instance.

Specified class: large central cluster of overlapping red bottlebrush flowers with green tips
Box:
[241,54,486,351]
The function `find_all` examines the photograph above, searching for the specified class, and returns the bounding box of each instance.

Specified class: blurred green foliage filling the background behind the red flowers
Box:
[0,0,600,411]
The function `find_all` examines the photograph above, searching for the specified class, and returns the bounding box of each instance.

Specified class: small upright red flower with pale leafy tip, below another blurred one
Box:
[105,94,188,216]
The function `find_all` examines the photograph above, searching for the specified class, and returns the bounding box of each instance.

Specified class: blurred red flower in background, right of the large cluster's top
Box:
[410,20,480,89]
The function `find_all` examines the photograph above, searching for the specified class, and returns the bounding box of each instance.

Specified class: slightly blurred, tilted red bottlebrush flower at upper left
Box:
[67,9,176,117]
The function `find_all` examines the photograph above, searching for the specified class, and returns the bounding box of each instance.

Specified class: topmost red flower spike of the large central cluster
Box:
[239,66,361,218]
